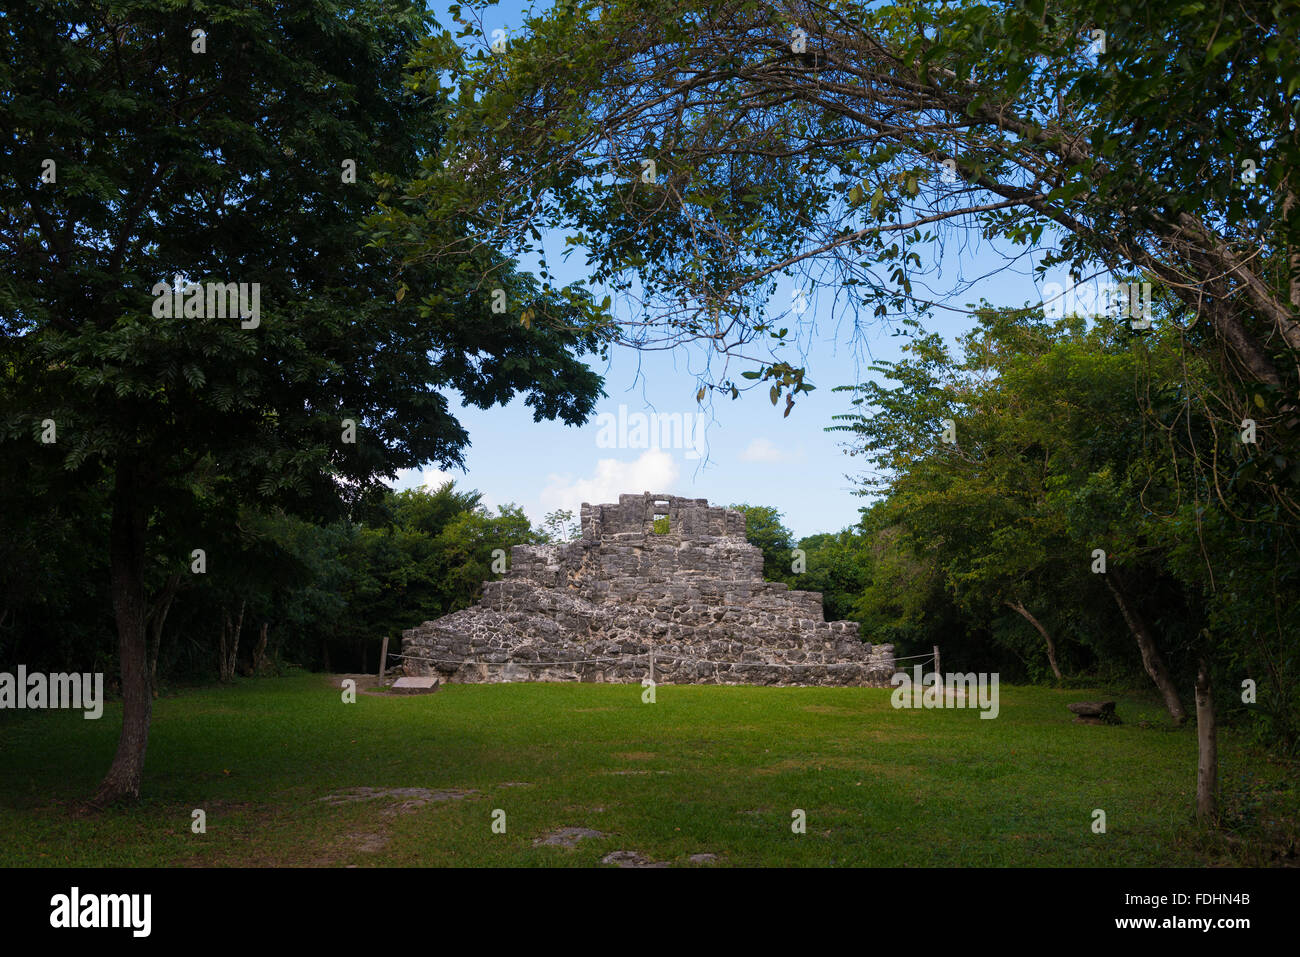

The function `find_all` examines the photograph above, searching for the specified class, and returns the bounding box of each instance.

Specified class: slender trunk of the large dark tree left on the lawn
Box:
[92,462,153,806]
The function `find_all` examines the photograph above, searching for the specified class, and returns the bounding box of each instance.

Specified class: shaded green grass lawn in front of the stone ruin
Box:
[0,675,1296,866]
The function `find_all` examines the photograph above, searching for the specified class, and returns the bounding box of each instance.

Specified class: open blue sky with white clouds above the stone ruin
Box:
[397,3,1061,537]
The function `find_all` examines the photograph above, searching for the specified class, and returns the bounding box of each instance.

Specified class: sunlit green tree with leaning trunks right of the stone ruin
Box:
[837,311,1186,702]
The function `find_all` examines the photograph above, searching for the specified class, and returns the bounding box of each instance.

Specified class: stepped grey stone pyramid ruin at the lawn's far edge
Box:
[402,492,894,687]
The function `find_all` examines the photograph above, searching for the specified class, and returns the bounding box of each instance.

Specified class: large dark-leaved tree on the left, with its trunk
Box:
[0,0,601,804]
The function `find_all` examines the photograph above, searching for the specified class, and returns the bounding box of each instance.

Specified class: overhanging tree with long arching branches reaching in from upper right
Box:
[384,0,1300,501]
